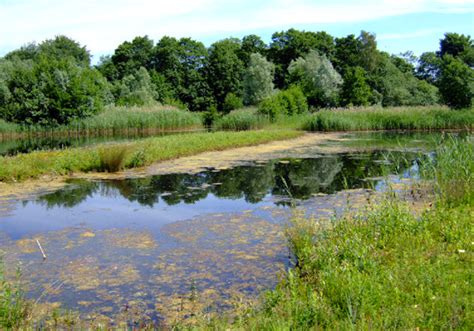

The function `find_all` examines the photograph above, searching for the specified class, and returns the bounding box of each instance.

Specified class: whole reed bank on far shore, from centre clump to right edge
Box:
[214,103,474,132]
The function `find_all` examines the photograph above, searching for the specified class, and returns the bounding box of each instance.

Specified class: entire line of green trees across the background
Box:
[0,29,474,125]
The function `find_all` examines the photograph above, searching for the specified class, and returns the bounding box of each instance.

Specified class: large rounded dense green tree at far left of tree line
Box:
[0,37,110,125]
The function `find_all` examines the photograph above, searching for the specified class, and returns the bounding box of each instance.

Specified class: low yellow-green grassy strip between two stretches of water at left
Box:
[0,130,302,181]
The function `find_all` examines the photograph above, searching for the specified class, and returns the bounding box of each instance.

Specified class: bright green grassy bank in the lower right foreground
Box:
[195,136,474,330]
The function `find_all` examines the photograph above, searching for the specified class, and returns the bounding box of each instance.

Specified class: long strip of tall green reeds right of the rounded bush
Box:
[303,107,474,131]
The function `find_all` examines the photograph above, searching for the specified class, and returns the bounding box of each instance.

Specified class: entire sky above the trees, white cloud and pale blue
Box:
[0,0,474,62]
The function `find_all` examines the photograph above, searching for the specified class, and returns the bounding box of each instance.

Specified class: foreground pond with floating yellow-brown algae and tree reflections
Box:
[0,134,440,325]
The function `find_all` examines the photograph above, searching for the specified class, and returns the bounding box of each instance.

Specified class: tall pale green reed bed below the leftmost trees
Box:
[0,105,202,138]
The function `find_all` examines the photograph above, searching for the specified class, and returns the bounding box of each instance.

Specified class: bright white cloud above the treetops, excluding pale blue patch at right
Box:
[0,0,474,54]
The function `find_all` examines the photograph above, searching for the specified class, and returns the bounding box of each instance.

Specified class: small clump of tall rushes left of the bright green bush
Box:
[214,108,269,131]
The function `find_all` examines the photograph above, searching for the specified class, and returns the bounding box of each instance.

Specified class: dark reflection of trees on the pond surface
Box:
[37,152,415,208]
